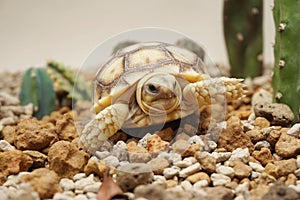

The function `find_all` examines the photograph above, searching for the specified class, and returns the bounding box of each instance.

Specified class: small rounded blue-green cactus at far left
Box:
[19,68,56,119]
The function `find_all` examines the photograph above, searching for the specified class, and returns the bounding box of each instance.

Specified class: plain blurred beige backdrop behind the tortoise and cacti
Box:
[0,0,274,70]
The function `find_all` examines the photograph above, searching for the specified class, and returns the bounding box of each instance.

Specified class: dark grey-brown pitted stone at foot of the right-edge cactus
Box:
[254,102,294,126]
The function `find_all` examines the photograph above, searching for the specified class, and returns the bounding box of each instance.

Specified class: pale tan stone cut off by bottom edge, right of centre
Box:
[204,186,234,200]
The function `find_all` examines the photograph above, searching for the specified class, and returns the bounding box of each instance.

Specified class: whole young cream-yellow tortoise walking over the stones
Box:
[80,42,245,152]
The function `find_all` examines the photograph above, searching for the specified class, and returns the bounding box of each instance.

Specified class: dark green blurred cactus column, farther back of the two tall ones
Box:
[223,0,263,78]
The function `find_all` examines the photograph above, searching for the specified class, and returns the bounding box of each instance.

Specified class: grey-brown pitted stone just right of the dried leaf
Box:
[116,163,153,192]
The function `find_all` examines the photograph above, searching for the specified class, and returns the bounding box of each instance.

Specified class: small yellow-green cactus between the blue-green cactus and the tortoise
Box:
[47,61,91,101]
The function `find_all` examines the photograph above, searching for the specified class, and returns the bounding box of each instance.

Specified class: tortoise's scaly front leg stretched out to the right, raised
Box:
[183,77,245,107]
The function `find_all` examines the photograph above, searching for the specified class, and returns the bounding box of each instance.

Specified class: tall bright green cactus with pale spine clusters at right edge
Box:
[273,0,300,122]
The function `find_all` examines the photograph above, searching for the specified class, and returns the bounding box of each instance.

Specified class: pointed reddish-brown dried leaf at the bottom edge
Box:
[97,170,128,200]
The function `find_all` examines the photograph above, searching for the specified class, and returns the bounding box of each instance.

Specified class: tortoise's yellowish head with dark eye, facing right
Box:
[136,73,182,116]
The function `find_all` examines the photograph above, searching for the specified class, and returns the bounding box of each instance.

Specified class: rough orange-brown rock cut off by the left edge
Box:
[0,150,33,181]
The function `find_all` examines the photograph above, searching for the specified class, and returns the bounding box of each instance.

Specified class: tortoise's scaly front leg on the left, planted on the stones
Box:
[80,103,129,152]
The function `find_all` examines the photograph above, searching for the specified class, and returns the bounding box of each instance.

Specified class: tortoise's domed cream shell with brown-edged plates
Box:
[93,42,209,113]
